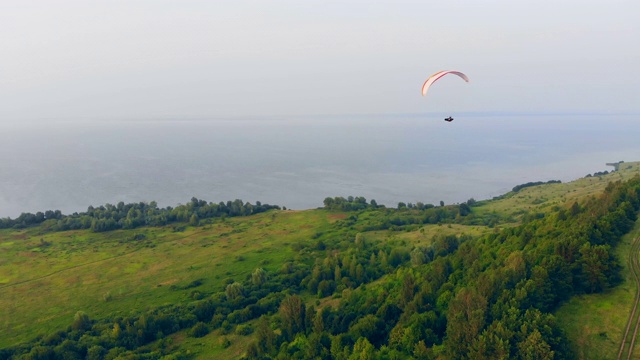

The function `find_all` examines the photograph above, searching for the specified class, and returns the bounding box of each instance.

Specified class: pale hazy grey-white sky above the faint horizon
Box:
[0,0,640,122]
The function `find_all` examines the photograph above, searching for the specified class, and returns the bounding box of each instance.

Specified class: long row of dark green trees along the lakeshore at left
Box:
[0,197,280,232]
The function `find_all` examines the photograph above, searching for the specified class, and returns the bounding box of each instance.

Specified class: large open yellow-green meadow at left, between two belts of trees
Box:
[0,211,332,347]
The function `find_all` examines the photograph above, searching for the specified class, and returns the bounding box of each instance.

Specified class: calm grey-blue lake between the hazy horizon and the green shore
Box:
[0,114,640,218]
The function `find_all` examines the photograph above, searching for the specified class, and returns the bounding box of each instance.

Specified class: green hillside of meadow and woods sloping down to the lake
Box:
[0,163,640,359]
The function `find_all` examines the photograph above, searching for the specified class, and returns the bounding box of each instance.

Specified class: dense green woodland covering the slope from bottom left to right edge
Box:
[0,178,640,359]
